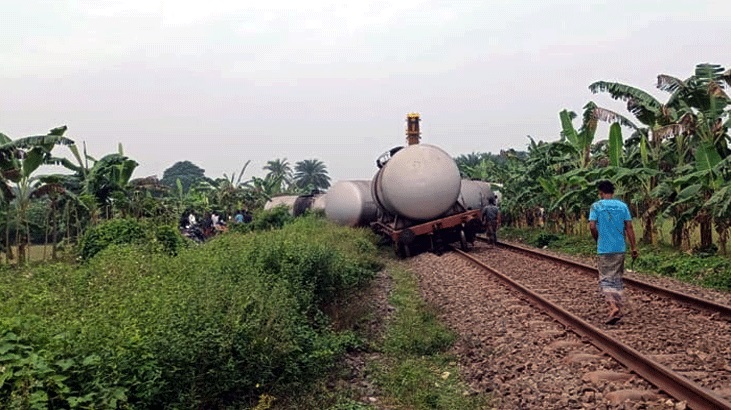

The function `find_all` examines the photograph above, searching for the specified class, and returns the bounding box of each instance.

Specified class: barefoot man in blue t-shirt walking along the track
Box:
[589,181,638,325]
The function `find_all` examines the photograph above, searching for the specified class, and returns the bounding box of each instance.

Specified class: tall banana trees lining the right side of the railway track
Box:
[457,63,731,253]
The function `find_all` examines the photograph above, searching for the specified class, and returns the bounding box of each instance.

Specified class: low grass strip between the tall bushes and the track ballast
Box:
[273,248,490,410]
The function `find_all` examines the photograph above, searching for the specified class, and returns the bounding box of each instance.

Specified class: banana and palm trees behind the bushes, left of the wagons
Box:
[0,130,330,263]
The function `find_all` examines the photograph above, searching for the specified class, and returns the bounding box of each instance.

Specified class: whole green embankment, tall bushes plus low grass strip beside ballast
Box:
[0,216,492,410]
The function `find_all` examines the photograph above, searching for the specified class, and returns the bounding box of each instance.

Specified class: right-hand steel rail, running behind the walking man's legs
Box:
[486,237,731,319]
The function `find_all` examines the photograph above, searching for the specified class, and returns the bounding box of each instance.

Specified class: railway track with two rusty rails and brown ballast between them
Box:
[456,240,731,409]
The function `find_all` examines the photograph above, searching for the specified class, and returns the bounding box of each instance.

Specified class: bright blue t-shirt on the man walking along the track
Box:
[589,198,632,255]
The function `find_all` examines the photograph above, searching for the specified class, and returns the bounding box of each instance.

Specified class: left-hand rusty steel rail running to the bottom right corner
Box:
[454,249,731,410]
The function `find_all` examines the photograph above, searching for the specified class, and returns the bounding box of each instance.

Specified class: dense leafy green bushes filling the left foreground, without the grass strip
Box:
[0,218,380,408]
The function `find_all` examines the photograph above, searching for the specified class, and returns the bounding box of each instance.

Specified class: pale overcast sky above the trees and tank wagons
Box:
[0,0,731,180]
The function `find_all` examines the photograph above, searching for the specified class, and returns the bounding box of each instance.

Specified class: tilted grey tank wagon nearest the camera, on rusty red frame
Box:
[370,114,483,257]
